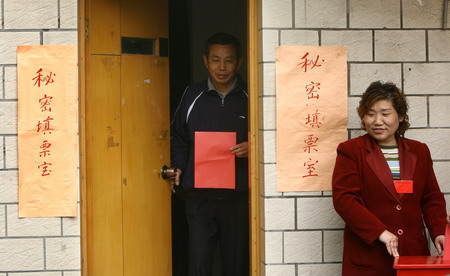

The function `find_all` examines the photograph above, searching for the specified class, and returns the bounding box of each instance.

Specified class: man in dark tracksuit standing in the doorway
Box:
[170,33,249,276]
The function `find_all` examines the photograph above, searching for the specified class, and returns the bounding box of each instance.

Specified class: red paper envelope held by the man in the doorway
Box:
[194,131,236,189]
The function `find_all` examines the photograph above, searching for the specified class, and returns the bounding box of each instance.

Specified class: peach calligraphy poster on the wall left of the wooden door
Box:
[17,45,78,217]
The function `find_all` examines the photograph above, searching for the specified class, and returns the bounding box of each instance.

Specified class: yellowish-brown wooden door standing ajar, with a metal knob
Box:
[82,0,172,276]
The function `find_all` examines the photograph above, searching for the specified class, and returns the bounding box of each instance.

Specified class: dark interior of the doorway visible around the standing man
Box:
[169,0,250,276]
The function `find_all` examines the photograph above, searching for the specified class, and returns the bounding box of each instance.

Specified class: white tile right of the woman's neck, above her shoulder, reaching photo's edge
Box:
[405,129,450,160]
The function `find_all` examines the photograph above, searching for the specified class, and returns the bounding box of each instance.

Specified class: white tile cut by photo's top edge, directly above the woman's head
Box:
[350,0,400,28]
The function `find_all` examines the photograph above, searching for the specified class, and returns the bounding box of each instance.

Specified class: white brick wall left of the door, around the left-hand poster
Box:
[0,0,81,276]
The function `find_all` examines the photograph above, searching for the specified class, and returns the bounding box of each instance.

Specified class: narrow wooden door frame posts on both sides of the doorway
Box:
[78,0,263,276]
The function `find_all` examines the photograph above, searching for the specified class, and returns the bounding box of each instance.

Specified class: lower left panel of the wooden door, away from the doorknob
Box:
[86,56,123,275]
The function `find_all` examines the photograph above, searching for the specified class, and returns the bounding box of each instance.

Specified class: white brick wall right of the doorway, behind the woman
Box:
[260,0,450,276]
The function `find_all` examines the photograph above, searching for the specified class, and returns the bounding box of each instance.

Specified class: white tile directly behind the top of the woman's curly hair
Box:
[350,63,402,95]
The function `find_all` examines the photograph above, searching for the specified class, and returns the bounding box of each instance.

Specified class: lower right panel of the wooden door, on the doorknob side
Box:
[121,55,172,276]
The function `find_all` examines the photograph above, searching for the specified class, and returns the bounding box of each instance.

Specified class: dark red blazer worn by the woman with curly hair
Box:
[333,134,446,276]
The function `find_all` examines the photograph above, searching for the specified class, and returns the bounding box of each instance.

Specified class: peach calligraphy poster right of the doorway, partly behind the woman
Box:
[276,46,347,192]
